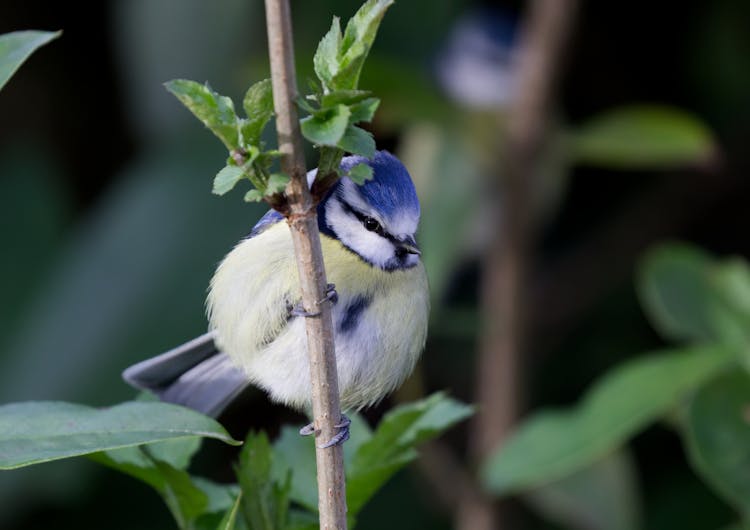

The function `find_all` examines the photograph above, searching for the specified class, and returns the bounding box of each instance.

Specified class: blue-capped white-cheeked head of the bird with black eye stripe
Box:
[318,151,420,271]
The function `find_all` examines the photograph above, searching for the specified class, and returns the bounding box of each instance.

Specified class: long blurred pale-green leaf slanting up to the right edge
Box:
[482,345,738,495]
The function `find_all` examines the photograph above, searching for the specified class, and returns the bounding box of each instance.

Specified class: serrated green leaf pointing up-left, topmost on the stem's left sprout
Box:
[164,79,242,151]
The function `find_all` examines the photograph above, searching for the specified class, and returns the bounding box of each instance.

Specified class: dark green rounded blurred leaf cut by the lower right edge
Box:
[685,369,750,517]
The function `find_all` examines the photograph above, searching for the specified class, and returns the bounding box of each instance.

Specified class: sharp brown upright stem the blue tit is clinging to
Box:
[266,0,346,530]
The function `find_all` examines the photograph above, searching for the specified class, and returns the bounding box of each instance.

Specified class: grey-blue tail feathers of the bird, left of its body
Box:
[122,331,249,417]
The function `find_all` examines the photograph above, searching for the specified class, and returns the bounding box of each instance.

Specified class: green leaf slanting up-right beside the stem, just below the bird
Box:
[346,393,474,516]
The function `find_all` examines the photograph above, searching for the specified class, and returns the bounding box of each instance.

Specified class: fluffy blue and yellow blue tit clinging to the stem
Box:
[123,151,430,443]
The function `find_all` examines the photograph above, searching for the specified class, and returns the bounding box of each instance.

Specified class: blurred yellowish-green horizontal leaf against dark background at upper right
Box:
[571,105,716,169]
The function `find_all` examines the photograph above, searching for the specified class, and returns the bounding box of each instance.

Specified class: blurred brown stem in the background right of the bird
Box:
[457,0,577,530]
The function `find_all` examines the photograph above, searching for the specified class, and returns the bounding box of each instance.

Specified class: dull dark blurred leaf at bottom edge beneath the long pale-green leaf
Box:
[524,450,643,530]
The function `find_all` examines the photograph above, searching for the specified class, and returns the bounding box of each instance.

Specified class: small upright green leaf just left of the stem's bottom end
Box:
[237,433,290,530]
